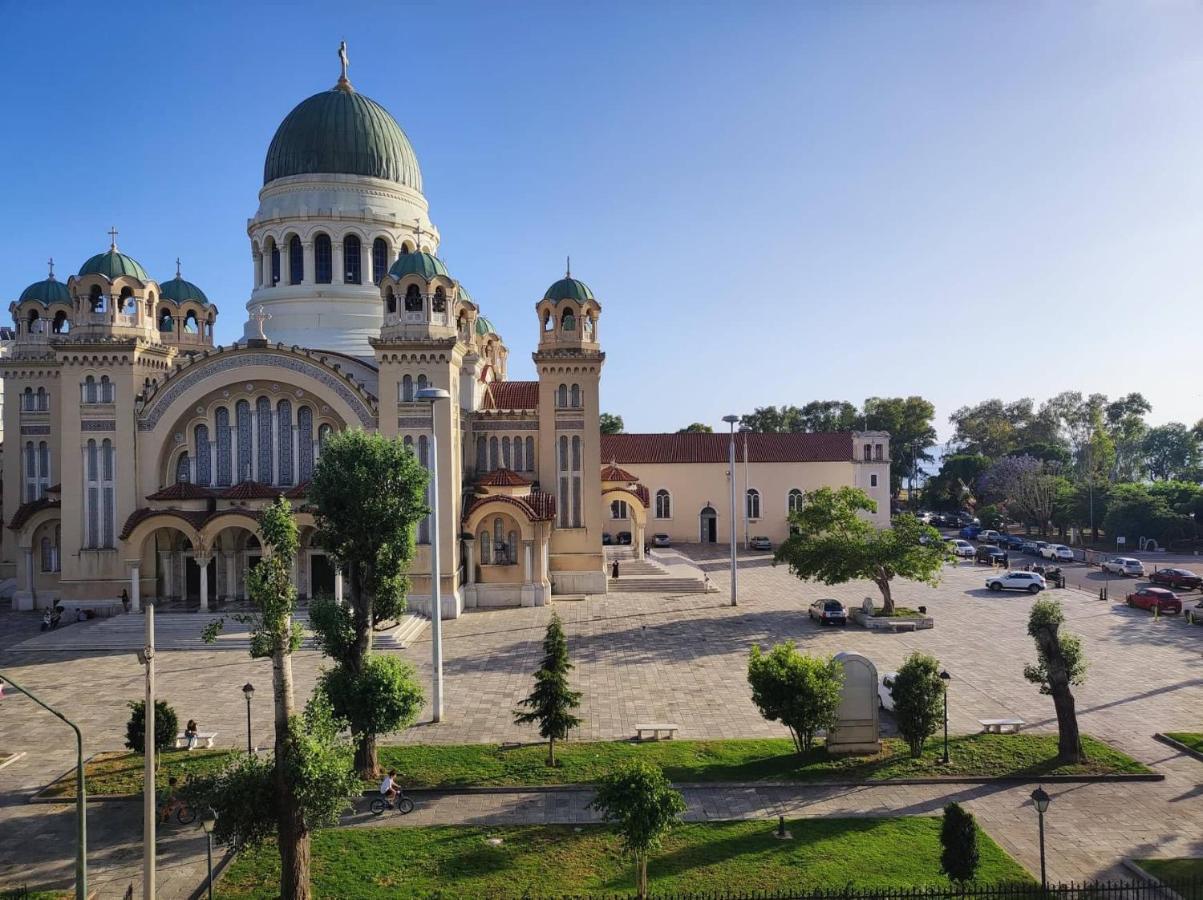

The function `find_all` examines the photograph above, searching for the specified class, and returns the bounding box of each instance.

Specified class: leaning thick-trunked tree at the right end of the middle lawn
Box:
[1024,600,1086,763]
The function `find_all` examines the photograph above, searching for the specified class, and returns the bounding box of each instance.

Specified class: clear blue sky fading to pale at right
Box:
[0,0,1203,438]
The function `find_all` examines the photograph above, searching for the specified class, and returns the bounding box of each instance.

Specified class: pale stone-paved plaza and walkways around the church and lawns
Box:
[0,546,1203,896]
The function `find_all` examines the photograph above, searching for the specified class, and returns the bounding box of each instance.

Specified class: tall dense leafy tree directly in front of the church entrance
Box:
[309,431,429,778]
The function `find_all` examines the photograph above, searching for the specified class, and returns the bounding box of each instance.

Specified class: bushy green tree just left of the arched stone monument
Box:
[748,641,843,752]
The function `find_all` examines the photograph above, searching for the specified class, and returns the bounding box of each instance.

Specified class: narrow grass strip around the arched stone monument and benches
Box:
[380,734,1149,787]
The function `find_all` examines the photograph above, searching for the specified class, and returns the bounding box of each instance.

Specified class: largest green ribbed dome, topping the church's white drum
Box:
[263,87,422,191]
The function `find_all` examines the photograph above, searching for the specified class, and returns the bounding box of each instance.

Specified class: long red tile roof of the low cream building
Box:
[602,432,853,466]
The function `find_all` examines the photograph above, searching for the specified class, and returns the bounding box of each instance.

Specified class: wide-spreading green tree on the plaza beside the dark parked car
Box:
[774,487,949,616]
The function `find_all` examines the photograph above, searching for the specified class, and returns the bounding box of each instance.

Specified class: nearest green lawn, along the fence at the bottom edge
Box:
[218,817,1031,900]
